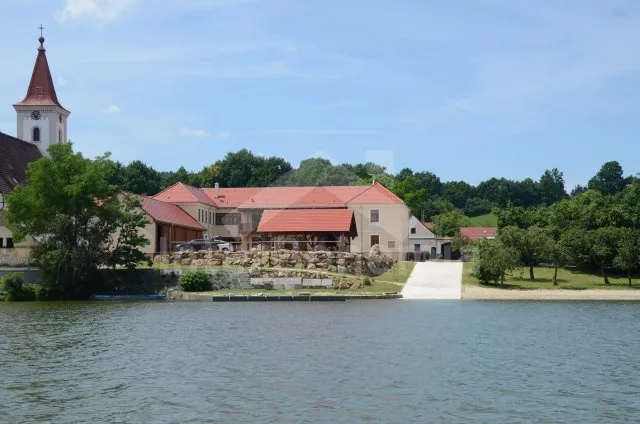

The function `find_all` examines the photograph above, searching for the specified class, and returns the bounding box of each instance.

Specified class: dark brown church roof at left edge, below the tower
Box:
[0,132,42,193]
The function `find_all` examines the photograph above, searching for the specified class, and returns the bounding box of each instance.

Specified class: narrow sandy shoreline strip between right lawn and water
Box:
[462,284,640,301]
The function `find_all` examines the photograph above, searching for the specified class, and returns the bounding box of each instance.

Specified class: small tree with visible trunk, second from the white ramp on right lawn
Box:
[498,226,550,280]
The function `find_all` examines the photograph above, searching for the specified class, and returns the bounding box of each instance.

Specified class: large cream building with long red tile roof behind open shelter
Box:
[153,183,409,258]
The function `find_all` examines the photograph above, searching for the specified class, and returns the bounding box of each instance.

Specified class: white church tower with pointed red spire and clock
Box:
[13,30,71,156]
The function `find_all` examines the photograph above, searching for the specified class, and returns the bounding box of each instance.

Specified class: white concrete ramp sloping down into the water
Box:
[402,261,462,299]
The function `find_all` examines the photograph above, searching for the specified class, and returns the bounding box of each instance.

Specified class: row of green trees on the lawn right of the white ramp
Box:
[470,178,640,287]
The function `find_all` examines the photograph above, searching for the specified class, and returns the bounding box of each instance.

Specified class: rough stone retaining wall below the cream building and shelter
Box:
[153,246,396,276]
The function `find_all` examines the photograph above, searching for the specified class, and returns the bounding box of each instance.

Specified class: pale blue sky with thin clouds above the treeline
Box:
[0,0,640,186]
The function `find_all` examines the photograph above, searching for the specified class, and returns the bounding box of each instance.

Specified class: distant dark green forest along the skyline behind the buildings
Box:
[110,149,636,221]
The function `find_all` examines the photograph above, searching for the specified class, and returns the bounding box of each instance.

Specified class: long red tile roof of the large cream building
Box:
[154,183,403,209]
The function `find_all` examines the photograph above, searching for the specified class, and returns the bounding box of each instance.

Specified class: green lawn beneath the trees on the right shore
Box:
[462,262,640,290]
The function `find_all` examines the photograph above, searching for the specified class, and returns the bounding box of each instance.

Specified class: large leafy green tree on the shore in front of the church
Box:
[5,144,148,298]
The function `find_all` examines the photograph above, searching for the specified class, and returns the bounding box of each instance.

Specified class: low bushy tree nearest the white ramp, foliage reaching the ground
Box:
[472,239,519,284]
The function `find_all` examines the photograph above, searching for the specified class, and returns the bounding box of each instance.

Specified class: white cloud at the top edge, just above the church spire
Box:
[57,0,137,22]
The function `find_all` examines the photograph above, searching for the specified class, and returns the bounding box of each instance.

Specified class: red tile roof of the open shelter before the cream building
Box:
[256,209,356,236]
